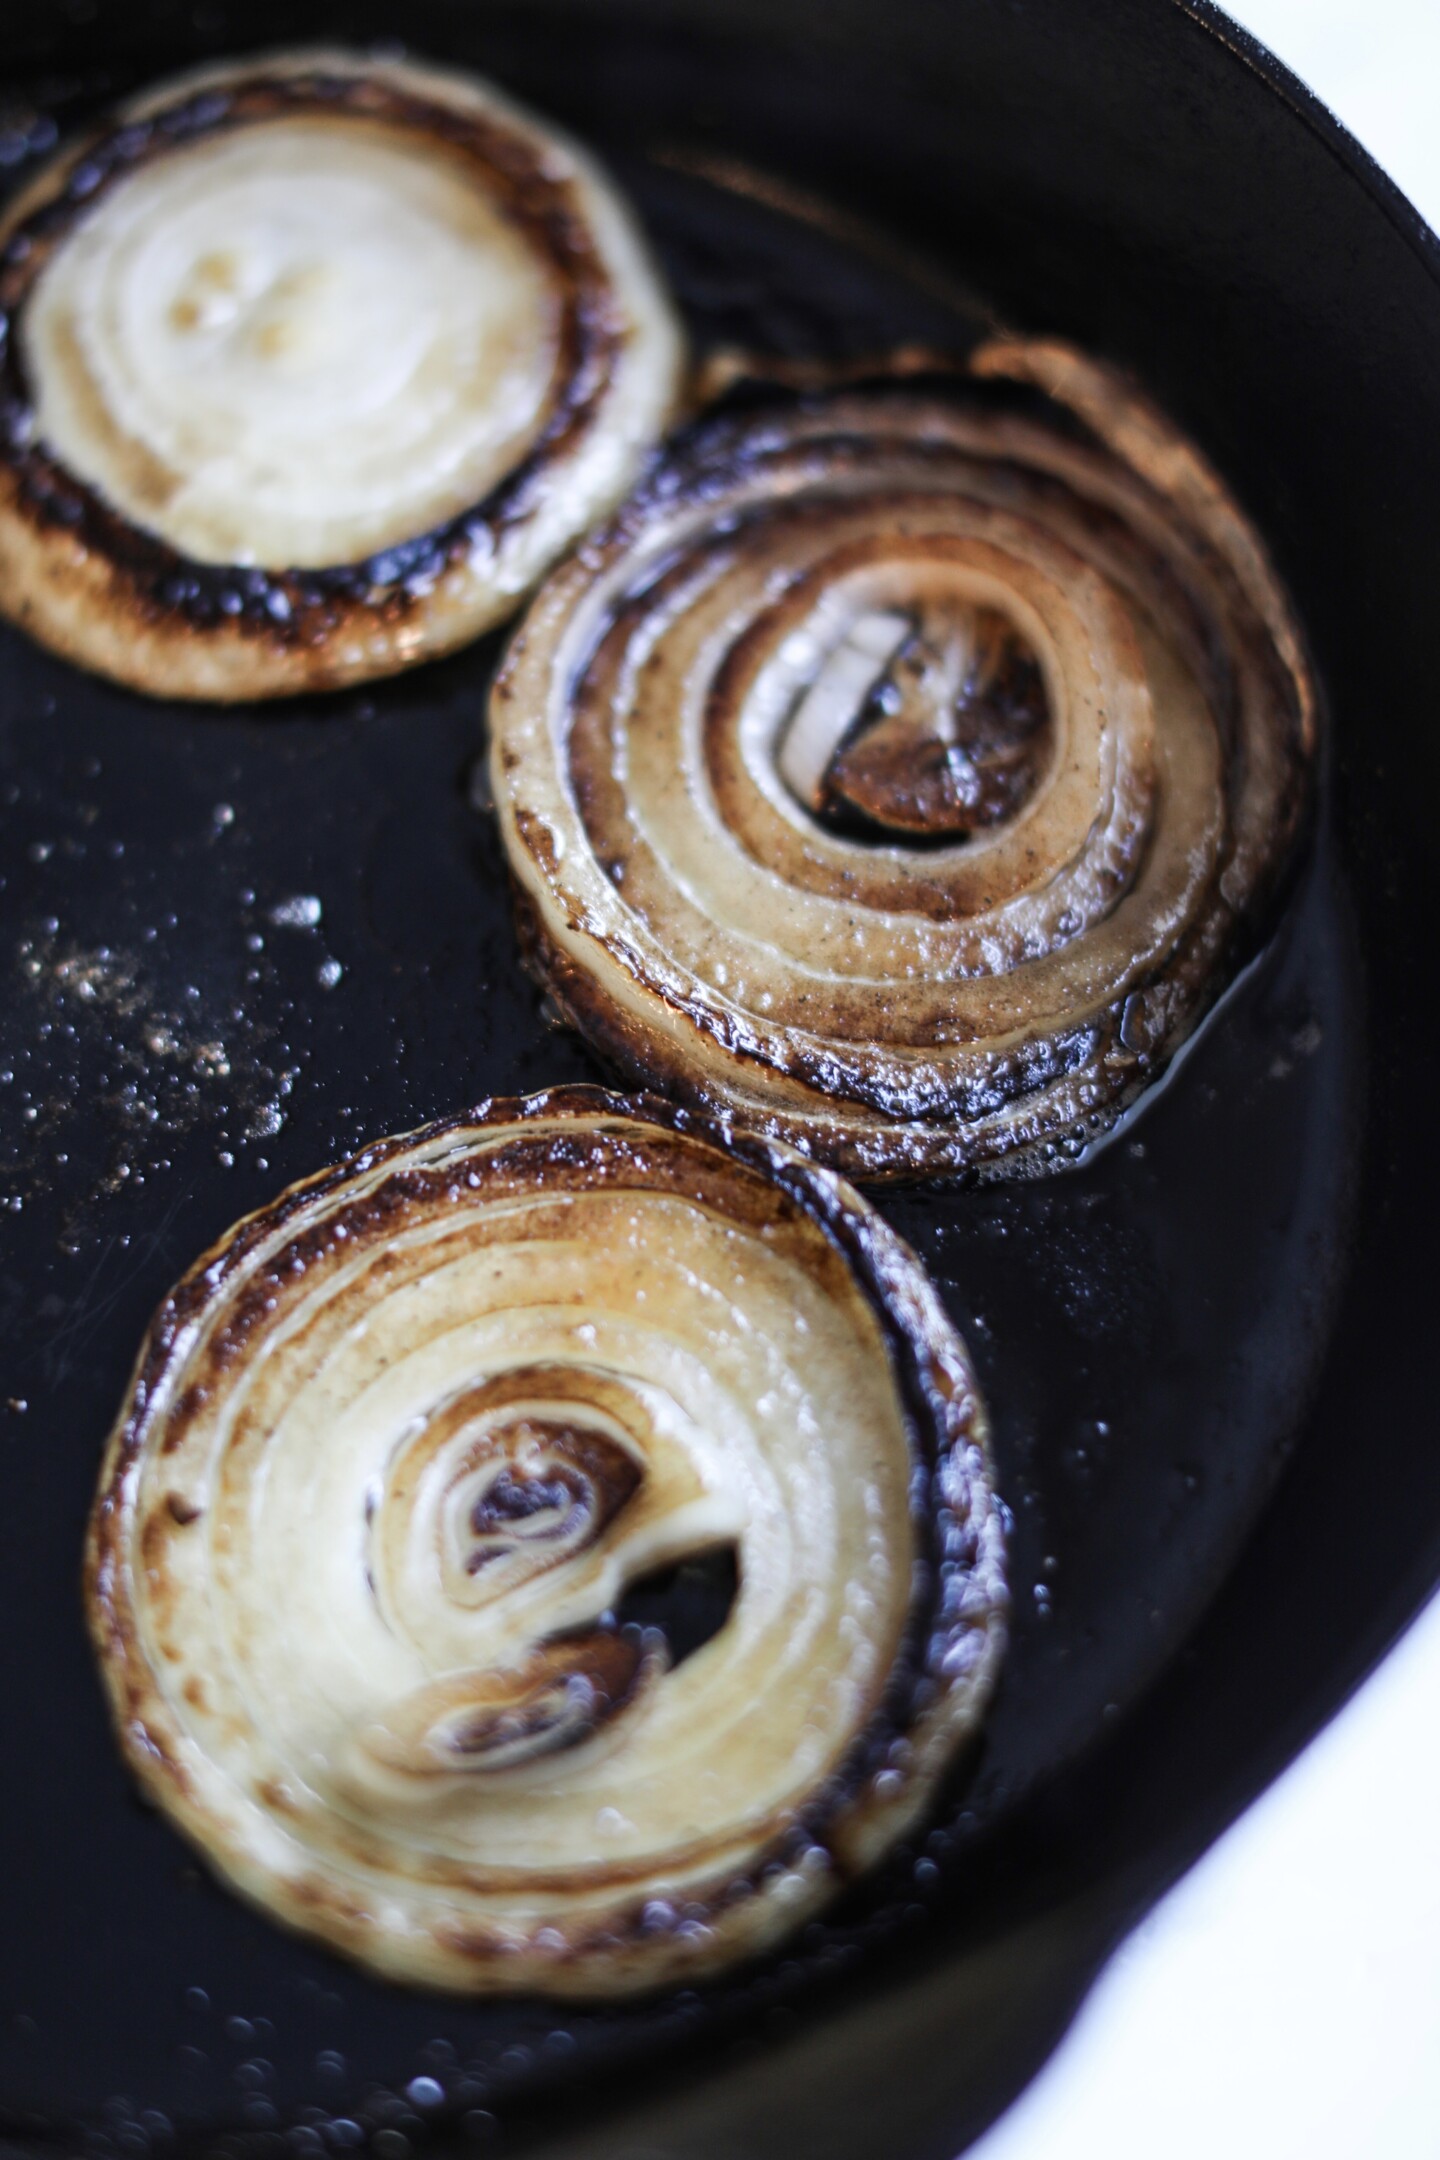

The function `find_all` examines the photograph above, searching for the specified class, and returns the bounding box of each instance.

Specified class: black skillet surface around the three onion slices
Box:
[0,0,1440,2160]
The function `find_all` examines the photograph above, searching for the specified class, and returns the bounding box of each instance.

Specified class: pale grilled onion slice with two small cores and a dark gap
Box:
[86,1089,1004,1996]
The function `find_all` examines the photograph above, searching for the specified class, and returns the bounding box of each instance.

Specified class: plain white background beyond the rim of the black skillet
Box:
[967,0,1440,2160]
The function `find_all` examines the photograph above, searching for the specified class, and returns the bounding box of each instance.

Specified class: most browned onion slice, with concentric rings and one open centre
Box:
[490,343,1315,1179]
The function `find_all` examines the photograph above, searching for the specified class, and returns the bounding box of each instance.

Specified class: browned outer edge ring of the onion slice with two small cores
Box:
[82,1084,1008,1998]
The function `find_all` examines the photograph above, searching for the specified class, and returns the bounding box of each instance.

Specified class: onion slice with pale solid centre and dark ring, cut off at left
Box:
[0,52,680,698]
